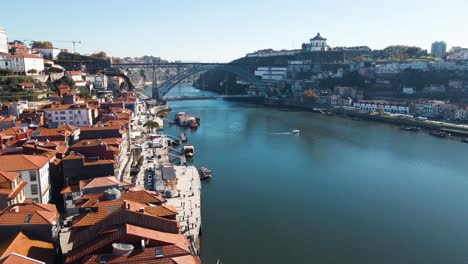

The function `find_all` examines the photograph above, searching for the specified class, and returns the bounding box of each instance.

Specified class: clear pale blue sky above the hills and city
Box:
[0,0,468,62]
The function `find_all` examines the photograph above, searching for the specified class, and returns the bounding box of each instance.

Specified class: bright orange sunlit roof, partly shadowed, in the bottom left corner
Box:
[0,232,55,263]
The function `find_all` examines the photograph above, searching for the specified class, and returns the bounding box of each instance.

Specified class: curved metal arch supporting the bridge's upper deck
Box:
[153,65,260,98]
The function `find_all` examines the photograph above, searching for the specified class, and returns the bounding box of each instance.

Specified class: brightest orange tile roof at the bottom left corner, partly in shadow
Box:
[0,232,54,259]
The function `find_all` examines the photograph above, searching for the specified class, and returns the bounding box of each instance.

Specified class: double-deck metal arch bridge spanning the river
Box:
[111,62,266,100]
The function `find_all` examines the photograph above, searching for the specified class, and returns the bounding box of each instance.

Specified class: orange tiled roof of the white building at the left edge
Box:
[0,154,50,171]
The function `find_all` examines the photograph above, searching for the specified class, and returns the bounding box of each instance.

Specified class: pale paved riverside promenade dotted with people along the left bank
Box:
[126,99,202,250]
